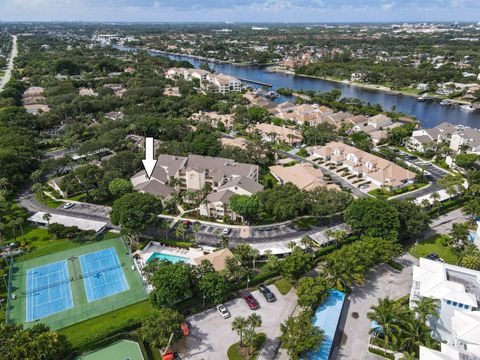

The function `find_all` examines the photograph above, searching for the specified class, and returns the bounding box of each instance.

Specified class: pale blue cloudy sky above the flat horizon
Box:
[0,0,480,23]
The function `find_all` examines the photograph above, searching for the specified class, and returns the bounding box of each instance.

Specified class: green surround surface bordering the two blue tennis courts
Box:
[8,238,147,329]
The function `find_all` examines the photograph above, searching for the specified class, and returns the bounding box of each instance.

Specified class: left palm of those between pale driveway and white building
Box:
[367,297,400,354]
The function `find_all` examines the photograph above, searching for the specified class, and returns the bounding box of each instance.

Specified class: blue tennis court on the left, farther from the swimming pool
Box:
[26,260,73,322]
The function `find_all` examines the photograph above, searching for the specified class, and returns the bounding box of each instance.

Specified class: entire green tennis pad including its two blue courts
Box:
[7,238,147,329]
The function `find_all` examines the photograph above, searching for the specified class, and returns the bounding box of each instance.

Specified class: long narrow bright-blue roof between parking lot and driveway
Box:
[305,290,345,360]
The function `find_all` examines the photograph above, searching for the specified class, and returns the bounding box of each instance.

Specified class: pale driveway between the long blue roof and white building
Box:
[331,254,418,360]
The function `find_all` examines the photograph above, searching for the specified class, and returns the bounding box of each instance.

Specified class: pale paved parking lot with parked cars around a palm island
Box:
[177,285,297,360]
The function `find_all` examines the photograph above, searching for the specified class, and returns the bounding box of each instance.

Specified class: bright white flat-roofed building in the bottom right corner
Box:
[410,258,480,360]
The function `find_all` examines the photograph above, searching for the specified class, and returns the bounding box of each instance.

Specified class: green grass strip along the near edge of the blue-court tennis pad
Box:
[58,300,153,348]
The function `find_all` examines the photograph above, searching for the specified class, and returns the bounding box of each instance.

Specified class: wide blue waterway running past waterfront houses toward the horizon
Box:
[118,46,480,128]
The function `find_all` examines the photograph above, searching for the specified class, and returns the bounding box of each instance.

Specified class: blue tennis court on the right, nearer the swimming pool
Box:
[80,247,128,302]
